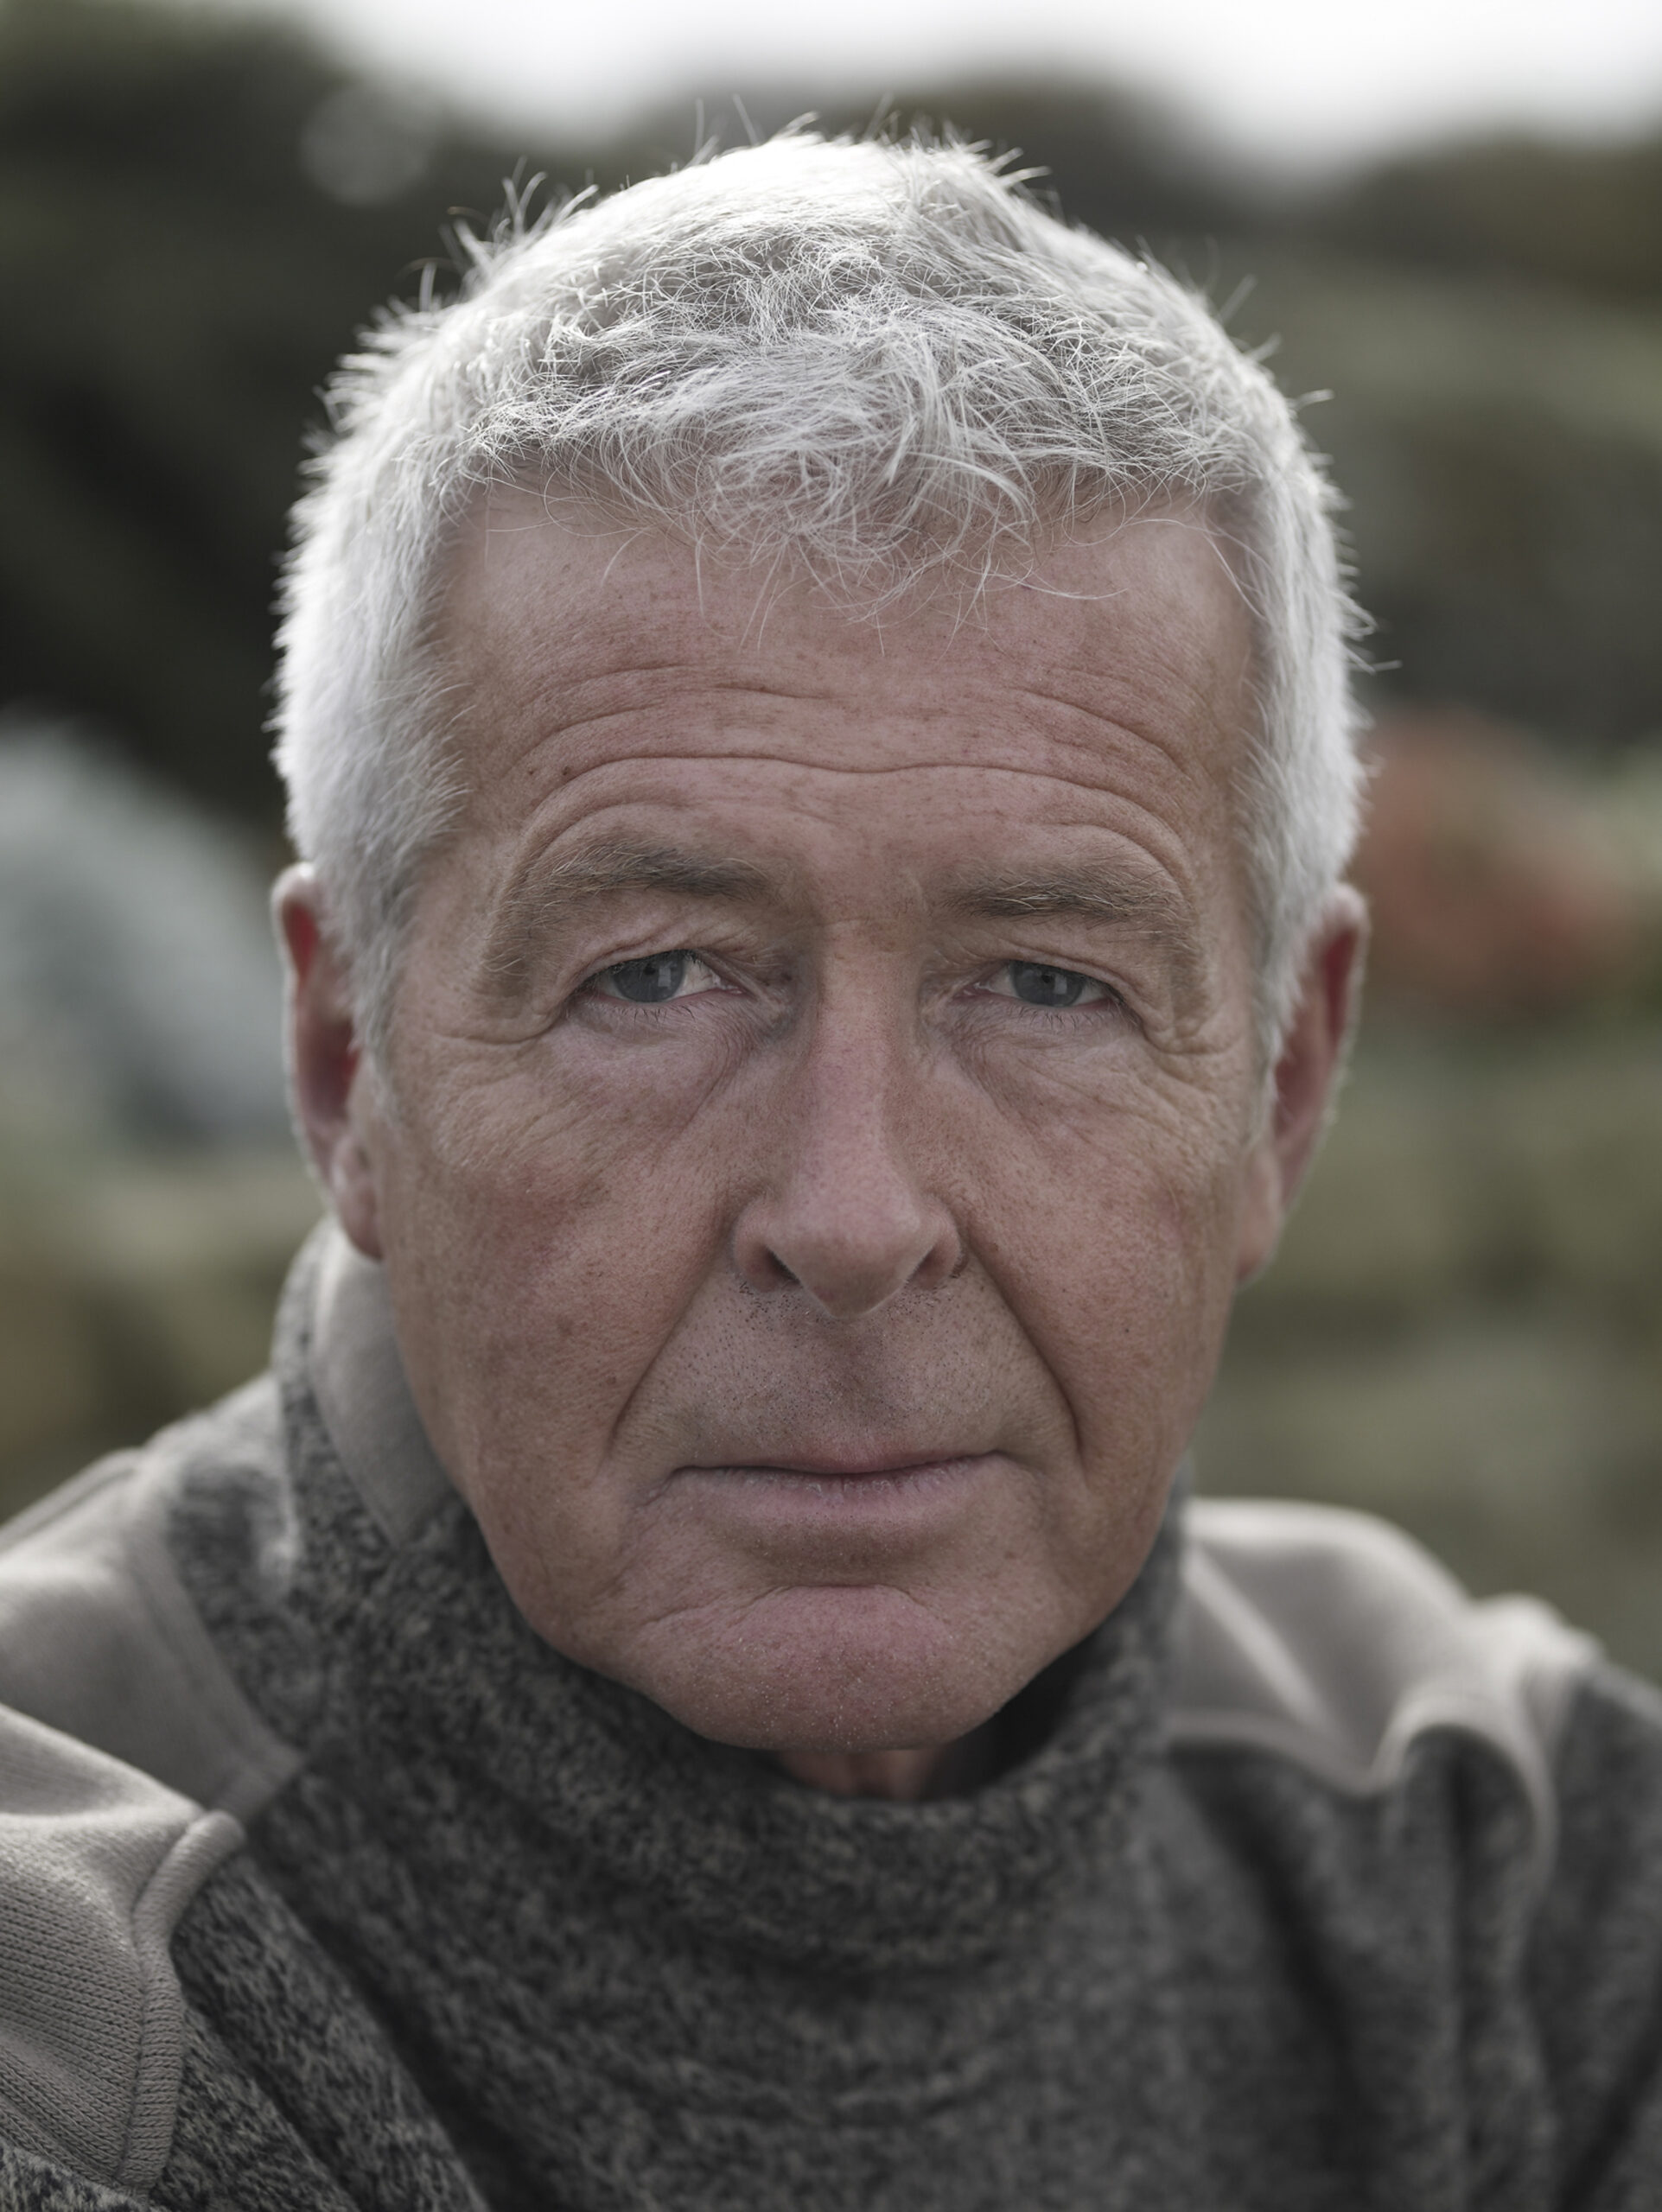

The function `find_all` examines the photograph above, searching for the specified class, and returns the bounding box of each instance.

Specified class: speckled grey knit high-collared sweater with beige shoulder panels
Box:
[0,1239,1662,2212]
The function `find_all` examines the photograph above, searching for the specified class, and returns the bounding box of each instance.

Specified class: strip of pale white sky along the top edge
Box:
[197,0,1662,166]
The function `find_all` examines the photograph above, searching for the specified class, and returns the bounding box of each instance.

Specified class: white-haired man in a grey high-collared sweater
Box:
[0,137,1662,2212]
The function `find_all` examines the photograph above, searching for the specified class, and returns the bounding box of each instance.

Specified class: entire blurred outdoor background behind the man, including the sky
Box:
[0,0,1662,1675]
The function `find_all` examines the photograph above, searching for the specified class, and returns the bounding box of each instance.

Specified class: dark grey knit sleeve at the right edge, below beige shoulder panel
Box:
[1531,1668,1662,2212]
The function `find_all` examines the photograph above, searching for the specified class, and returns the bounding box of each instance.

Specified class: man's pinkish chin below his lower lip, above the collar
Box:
[607,1586,1044,1752]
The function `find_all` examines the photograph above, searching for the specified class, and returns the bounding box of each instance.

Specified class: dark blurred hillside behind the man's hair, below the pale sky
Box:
[0,0,1662,821]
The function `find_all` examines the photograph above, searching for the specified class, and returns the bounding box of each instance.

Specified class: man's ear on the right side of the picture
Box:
[1235,882,1367,1283]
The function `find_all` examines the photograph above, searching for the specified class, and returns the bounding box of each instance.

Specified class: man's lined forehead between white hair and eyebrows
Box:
[441,491,1252,867]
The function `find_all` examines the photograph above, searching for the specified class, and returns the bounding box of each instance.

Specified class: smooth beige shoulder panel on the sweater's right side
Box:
[1171,1500,1600,1880]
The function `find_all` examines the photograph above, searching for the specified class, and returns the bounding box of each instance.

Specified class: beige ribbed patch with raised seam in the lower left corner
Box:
[0,1707,241,2195]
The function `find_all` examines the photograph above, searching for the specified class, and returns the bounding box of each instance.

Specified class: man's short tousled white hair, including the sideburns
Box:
[277,133,1359,1048]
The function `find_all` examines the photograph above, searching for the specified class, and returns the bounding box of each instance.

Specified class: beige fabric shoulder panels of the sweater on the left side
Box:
[0,1380,299,2196]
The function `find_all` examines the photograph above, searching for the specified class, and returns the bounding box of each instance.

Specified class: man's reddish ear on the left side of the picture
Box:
[272,865,380,1259]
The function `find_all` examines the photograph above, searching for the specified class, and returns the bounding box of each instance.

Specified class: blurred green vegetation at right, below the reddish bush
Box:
[1195,1020,1662,1676]
